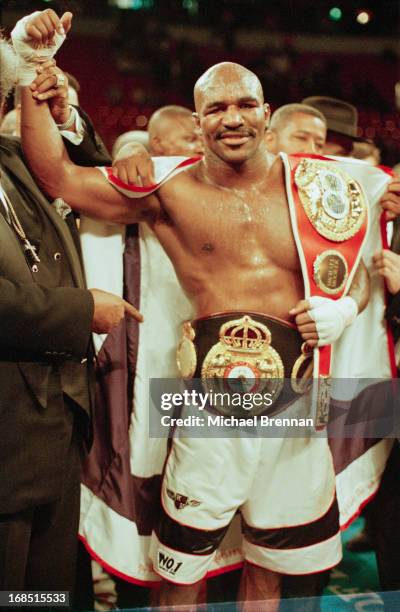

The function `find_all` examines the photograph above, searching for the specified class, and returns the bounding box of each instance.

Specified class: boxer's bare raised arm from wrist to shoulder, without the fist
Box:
[21,87,160,223]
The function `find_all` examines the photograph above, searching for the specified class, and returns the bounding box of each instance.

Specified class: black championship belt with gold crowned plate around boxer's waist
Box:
[178,311,312,414]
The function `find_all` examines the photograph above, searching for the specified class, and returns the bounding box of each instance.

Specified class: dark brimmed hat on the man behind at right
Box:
[302,96,365,142]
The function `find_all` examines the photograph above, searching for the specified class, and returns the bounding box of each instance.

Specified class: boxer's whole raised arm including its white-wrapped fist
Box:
[12,9,160,223]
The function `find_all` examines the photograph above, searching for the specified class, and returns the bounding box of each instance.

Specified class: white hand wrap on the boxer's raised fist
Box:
[11,11,65,85]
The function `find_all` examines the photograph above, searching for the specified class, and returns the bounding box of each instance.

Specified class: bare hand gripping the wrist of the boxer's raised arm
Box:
[30,59,71,124]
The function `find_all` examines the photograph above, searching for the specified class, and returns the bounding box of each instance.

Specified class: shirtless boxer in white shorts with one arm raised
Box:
[18,10,368,609]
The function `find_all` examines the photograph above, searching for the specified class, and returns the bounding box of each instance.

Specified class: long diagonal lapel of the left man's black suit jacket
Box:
[1,141,85,288]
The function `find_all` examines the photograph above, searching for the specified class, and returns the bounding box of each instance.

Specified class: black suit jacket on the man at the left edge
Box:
[0,120,107,515]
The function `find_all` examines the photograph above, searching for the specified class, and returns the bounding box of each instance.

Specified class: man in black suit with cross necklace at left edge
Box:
[0,31,140,597]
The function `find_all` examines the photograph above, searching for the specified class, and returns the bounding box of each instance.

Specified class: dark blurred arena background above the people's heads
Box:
[1,0,400,165]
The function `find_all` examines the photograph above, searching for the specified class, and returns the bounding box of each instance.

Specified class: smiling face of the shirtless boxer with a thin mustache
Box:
[197,71,269,164]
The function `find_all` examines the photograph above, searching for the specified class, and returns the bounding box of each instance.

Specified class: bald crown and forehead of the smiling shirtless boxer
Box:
[194,62,264,112]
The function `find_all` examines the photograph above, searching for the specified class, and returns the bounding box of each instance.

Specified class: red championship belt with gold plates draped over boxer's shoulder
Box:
[287,156,368,426]
